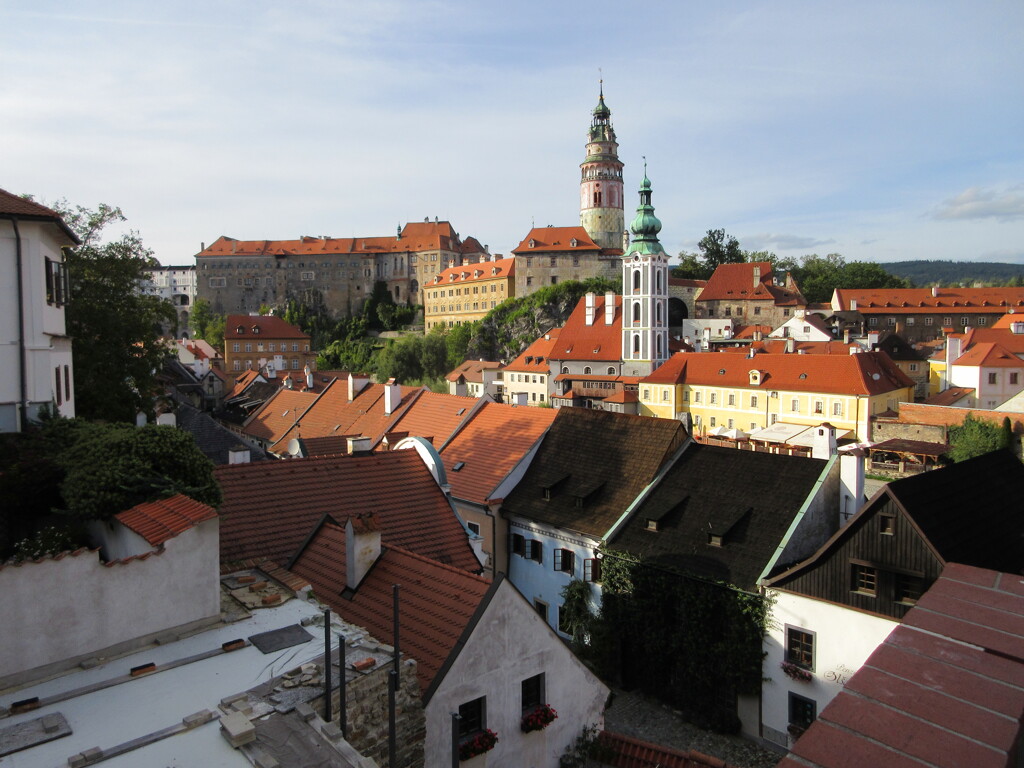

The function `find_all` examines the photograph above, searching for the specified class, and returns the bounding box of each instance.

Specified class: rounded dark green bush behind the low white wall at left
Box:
[57,424,221,520]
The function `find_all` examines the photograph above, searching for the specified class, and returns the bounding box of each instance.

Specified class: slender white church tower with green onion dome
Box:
[623,163,669,376]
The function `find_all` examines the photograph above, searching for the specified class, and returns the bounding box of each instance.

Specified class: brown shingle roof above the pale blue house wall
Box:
[502,408,687,536]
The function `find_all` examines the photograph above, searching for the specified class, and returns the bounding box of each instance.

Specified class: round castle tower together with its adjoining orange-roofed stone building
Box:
[512,85,627,296]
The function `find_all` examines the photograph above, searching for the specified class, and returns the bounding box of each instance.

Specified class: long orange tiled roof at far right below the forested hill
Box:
[835,288,1024,315]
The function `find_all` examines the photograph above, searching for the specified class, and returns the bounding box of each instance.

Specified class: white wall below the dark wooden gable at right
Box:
[761,590,898,748]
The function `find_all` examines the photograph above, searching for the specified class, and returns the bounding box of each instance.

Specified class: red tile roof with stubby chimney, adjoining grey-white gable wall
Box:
[291,524,492,692]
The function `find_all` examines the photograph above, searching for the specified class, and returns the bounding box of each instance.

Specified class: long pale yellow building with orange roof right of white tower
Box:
[640,352,913,441]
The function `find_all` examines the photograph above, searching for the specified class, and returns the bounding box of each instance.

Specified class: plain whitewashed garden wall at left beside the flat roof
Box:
[0,519,220,677]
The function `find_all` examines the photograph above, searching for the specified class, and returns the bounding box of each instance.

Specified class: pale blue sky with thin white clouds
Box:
[0,0,1024,264]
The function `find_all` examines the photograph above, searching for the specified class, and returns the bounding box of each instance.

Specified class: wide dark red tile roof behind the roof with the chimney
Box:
[214,451,480,571]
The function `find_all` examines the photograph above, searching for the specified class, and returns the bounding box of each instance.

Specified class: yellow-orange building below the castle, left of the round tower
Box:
[423,258,515,333]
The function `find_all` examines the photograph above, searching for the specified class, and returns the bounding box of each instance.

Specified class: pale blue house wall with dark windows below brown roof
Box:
[508,517,601,638]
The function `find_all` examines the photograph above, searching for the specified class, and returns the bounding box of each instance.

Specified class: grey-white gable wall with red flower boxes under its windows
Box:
[426,580,608,768]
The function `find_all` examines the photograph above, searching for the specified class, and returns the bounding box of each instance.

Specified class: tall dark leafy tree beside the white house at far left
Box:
[53,201,177,422]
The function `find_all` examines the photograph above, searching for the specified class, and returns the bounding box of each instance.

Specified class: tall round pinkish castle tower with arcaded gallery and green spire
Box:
[580,80,626,250]
